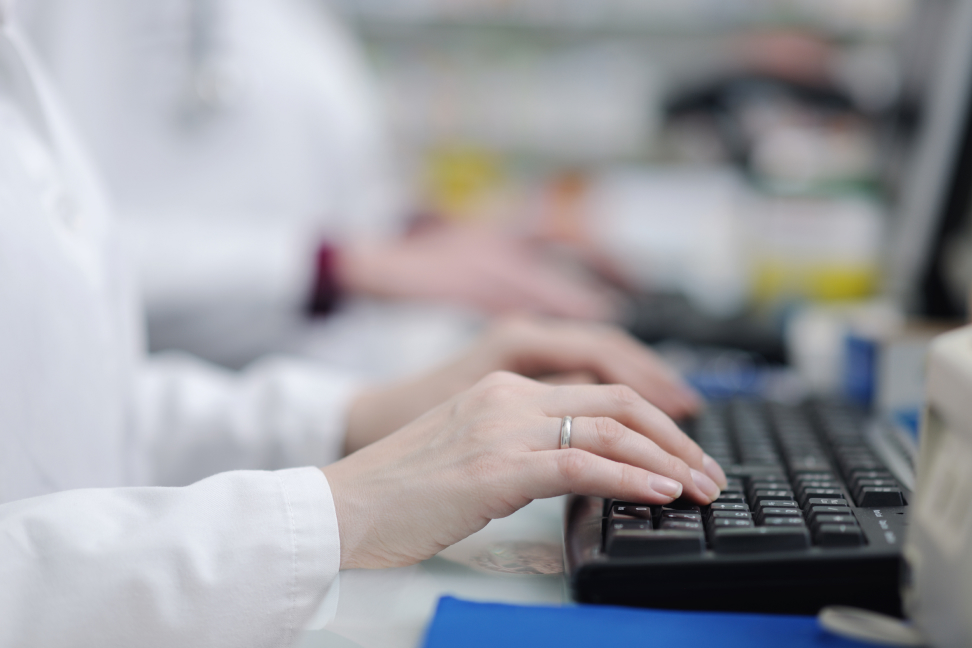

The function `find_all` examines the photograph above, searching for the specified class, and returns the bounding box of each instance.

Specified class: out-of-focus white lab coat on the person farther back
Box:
[24,0,410,366]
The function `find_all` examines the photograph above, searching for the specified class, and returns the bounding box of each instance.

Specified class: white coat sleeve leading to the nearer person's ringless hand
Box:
[133,353,360,486]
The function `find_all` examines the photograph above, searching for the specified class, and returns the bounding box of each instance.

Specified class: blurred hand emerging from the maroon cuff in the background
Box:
[337,226,617,320]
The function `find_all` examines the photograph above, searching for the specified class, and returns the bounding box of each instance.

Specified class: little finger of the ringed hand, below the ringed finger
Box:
[517,448,682,504]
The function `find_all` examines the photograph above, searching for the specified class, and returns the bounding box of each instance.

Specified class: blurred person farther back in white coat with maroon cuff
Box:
[21,0,615,375]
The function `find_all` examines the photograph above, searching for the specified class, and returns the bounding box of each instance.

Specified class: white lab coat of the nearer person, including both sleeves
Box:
[0,12,354,648]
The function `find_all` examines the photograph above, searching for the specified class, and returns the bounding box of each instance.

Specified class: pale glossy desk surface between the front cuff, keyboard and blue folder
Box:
[297,498,569,648]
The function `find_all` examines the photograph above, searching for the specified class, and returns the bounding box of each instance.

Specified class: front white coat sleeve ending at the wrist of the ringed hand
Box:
[0,468,340,648]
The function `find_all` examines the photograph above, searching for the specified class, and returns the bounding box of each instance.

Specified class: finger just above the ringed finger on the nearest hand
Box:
[540,385,725,485]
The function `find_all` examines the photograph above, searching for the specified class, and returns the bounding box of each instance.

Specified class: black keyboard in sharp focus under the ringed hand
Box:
[564,401,911,615]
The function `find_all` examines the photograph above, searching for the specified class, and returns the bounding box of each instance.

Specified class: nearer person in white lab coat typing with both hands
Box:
[0,7,725,648]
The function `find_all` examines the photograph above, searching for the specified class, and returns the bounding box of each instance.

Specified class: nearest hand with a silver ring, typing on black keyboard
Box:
[323,372,726,569]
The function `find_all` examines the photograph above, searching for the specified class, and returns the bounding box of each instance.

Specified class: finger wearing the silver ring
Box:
[537,417,719,504]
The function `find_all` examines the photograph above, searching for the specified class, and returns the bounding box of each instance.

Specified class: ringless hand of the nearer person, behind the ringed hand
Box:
[345,317,701,452]
